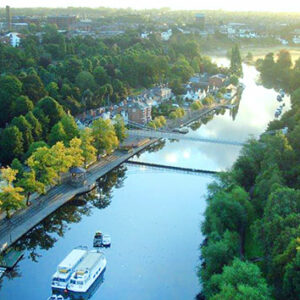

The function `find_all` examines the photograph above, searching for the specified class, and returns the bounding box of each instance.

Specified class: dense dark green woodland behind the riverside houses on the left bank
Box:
[0,25,218,165]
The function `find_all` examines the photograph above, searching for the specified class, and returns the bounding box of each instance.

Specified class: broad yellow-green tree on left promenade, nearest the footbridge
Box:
[92,118,119,154]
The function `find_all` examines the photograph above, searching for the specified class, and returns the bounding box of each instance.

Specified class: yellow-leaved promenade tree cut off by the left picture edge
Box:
[0,167,24,218]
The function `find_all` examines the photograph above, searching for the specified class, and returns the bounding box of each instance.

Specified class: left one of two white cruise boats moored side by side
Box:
[51,247,88,289]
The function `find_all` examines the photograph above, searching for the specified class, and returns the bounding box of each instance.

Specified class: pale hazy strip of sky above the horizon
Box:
[2,0,300,12]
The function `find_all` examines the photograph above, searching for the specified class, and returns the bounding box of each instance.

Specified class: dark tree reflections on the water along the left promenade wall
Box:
[15,166,126,262]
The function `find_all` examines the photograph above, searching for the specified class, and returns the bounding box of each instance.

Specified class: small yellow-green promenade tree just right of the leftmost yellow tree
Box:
[17,170,46,206]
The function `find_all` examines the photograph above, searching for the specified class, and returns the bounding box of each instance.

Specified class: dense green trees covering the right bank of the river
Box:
[199,51,300,300]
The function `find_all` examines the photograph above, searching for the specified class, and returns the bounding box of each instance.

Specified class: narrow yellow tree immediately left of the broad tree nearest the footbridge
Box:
[80,128,97,167]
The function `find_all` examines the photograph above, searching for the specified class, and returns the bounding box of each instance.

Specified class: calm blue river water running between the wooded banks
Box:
[0,59,289,300]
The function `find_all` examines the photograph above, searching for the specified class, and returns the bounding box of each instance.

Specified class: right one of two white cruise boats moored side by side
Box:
[67,250,106,293]
